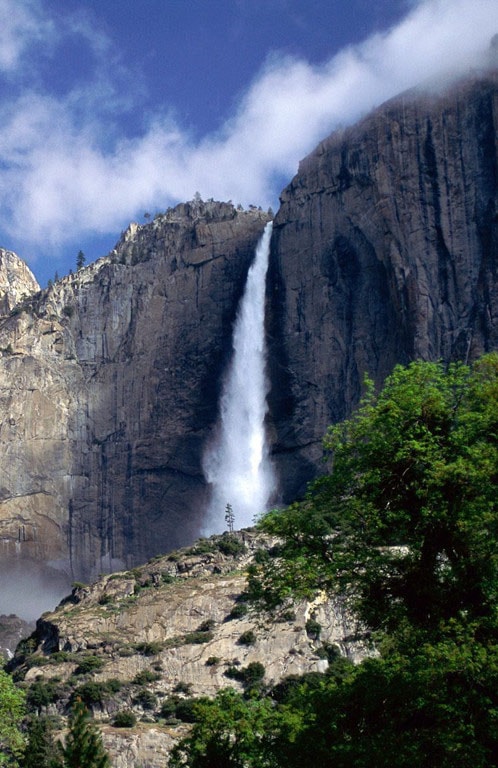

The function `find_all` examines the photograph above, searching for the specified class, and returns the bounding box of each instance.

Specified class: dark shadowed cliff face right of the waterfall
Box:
[268,72,498,500]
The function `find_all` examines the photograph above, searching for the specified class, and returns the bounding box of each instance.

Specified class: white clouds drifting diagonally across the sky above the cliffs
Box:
[0,0,498,258]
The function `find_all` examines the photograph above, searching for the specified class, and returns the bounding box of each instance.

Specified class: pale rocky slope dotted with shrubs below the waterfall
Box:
[12,531,365,768]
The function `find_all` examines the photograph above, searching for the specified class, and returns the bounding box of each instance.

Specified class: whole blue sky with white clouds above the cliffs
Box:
[0,0,498,285]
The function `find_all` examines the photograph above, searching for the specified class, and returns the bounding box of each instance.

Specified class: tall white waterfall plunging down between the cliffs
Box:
[203,222,276,535]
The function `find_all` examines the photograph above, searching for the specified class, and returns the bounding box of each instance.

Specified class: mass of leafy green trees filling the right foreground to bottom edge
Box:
[170,354,498,768]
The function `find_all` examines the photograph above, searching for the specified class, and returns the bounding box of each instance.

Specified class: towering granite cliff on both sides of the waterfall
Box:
[0,72,498,596]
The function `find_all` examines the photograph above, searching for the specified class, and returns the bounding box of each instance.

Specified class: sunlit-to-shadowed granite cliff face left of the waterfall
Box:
[0,201,269,584]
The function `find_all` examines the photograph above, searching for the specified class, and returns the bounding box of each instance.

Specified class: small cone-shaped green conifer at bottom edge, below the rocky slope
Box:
[62,699,110,768]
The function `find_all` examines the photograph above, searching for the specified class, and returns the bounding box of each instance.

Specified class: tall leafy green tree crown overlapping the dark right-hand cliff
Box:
[252,354,498,632]
